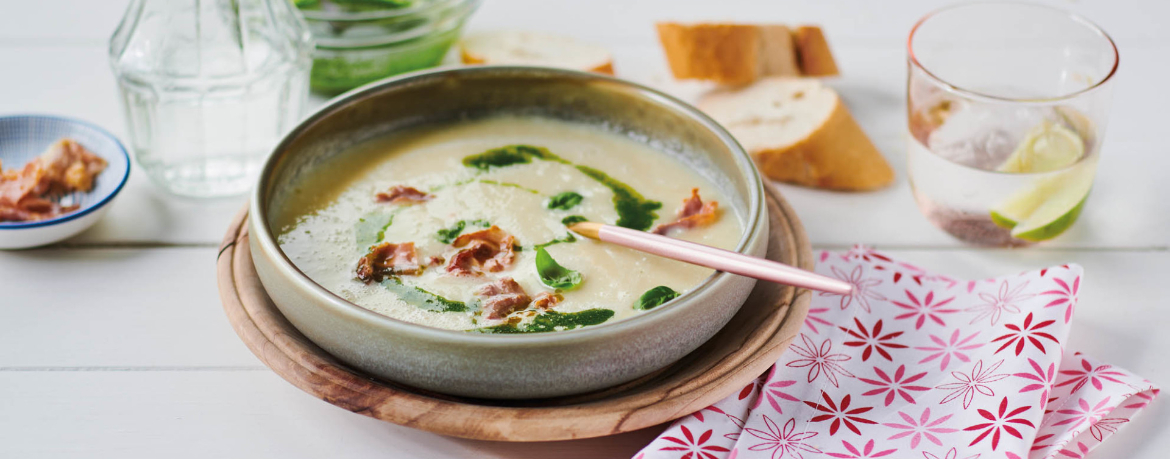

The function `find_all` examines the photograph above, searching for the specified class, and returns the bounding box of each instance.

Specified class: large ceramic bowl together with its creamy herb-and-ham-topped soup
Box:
[248,67,768,399]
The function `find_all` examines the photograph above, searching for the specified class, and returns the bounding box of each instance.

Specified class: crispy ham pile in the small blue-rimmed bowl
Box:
[0,138,108,221]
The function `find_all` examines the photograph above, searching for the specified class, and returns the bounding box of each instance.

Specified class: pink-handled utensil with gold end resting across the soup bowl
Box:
[569,221,853,295]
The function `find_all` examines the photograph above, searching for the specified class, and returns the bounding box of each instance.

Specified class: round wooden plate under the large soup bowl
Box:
[216,187,813,441]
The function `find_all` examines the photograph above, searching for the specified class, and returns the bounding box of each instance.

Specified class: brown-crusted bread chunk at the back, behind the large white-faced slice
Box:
[658,22,799,84]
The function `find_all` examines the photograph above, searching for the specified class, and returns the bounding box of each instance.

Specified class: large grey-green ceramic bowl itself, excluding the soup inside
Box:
[248,67,768,398]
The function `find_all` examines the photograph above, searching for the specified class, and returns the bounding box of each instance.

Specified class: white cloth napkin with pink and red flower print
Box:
[636,247,1158,459]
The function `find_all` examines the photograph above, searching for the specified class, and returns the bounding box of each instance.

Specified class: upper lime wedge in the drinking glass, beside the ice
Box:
[999,121,1085,173]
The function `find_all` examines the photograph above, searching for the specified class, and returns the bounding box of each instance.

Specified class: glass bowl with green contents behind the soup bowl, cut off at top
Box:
[296,0,482,94]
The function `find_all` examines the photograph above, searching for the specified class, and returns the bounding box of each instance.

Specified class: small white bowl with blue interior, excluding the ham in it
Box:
[0,115,130,249]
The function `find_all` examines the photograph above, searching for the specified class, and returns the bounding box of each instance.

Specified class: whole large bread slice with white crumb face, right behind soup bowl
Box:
[698,77,894,191]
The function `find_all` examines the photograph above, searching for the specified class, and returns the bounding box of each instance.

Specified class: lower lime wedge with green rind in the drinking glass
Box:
[991,162,1096,241]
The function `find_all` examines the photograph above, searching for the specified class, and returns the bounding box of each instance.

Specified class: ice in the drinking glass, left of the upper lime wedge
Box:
[927,103,1060,171]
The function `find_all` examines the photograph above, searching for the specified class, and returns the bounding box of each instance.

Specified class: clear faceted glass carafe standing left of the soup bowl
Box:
[109,0,312,198]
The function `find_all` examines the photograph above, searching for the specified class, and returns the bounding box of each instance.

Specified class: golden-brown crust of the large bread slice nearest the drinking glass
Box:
[752,97,894,191]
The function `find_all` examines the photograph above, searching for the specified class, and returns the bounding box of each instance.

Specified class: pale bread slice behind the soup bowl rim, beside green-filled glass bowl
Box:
[460,30,613,75]
